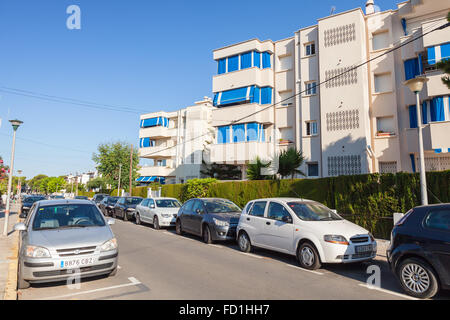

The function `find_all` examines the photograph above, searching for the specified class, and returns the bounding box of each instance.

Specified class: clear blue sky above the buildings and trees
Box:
[0,0,400,178]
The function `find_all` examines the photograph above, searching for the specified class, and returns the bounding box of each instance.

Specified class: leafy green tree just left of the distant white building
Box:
[92,141,139,190]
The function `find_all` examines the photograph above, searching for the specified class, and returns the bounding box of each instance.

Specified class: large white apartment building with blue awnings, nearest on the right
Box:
[210,0,450,178]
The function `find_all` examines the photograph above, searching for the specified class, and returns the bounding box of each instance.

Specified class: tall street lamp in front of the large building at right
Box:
[403,77,428,205]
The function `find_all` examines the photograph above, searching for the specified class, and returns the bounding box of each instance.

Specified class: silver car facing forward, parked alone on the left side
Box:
[14,200,119,289]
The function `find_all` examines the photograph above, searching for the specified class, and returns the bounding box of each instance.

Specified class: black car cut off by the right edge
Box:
[387,203,450,298]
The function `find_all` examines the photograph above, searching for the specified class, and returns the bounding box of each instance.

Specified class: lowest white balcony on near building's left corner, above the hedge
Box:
[210,142,273,164]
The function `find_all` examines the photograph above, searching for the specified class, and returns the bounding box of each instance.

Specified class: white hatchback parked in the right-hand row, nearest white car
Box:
[236,198,377,270]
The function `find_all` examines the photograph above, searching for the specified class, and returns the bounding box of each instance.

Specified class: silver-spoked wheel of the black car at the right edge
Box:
[397,258,439,299]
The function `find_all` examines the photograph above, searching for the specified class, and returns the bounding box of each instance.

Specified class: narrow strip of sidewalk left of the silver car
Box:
[0,204,19,300]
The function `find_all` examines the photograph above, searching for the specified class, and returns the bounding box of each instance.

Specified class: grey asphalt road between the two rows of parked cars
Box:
[19,220,450,300]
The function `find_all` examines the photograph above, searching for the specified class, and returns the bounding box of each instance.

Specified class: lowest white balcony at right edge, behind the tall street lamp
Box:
[406,121,450,153]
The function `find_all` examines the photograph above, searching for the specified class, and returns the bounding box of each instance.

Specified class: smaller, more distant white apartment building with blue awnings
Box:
[137,97,214,185]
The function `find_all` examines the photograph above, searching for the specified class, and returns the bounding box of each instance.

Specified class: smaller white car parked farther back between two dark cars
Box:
[135,198,181,230]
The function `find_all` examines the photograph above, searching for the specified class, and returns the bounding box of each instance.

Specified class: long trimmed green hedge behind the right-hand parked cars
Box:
[162,171,450,239]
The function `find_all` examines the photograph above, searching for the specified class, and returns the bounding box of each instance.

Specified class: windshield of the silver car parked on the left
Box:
[33,204,105,230]
